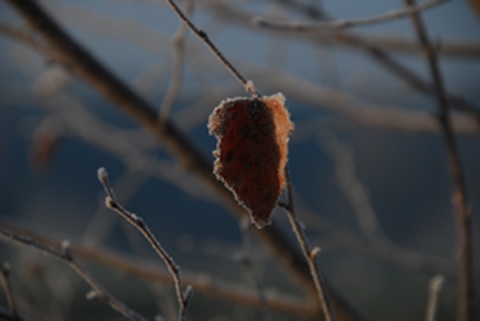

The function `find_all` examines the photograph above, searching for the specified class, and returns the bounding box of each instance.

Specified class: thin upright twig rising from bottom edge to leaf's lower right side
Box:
[279,168,335,321]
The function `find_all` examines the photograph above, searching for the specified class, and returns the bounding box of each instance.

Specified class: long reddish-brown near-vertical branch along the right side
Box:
[405,0,474,321]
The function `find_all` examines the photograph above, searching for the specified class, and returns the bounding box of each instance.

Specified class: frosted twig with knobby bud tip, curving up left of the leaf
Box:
[98,167,193,321]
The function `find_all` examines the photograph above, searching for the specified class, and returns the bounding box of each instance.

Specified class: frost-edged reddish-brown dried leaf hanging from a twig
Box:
[208,93,293,228]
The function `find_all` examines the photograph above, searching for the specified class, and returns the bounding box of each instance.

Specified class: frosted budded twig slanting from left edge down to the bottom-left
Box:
[0,226,146,321]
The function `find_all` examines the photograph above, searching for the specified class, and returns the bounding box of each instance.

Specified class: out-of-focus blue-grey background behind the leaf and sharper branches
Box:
[0,0,480,321]
